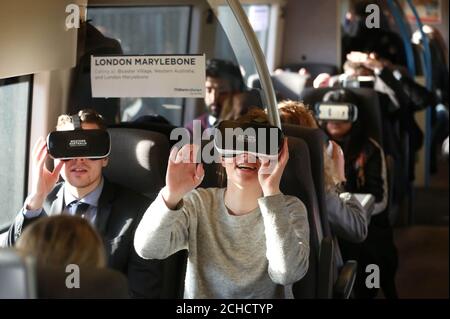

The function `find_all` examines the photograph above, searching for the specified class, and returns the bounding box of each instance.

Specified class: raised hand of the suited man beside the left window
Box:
[25,137,64,210]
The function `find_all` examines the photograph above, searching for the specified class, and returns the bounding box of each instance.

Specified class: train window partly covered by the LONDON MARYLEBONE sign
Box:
[88,6,192,124]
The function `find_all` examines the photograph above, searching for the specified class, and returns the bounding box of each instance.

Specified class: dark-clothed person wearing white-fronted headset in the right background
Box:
[321,90,398,298]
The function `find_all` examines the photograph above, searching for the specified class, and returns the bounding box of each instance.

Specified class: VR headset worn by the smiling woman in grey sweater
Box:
[214,121,284,159]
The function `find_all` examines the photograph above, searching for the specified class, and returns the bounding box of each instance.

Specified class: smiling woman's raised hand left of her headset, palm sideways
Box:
[162,144,205,209]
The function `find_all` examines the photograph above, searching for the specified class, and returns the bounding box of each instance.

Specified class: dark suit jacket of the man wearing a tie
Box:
[7,179,163,298]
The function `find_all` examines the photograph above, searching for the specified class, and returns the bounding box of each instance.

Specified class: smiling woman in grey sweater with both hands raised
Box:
[134,111,309,299]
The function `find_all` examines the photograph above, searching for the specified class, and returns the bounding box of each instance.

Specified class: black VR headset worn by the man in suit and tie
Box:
[47,115,111,160]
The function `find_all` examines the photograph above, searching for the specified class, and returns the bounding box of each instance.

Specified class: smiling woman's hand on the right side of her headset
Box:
[258,138,289,196]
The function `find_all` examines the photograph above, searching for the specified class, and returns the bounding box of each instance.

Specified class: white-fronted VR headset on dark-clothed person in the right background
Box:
[314,102,358,122]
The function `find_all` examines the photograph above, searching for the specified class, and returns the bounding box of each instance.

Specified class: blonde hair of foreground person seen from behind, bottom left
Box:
[16,215,106,267]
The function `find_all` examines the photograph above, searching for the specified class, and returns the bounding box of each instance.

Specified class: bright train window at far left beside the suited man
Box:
[0,76,32,230]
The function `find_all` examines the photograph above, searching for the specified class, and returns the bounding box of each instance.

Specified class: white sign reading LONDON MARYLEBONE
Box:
[91,55,206,98]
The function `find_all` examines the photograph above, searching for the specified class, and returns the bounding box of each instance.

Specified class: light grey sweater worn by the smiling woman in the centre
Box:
[134,188,309,298]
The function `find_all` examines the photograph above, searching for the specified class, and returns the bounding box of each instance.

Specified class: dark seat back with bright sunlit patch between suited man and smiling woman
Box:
[104,123,187,298]
